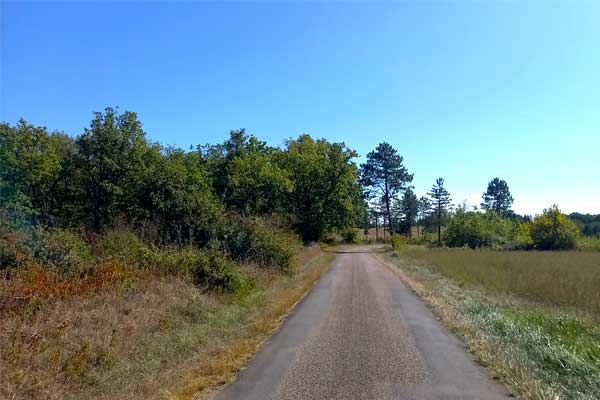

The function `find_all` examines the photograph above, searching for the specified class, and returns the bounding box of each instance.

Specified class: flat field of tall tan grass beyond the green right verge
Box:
[403,246,600,316]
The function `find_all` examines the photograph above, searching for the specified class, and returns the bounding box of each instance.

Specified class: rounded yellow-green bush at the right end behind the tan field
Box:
[531,205,579,250]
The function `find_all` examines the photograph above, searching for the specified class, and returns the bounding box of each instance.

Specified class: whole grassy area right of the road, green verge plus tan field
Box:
[382,247,600,400]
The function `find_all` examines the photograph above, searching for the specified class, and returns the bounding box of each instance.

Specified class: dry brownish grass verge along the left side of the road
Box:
[0,246,333,399]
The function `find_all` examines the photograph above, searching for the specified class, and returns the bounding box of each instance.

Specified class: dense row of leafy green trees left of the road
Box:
[0,108,364,276]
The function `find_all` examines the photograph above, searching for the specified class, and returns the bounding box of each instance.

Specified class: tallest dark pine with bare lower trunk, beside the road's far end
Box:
[360,142,413,233]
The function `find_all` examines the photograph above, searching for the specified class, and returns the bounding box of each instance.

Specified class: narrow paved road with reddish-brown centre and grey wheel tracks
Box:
[214,247,509,400]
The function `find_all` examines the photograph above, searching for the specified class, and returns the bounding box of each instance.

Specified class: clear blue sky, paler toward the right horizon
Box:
[0,0,600,213]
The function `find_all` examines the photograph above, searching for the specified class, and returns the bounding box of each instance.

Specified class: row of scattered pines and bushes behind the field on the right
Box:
[360,142,594,249]
